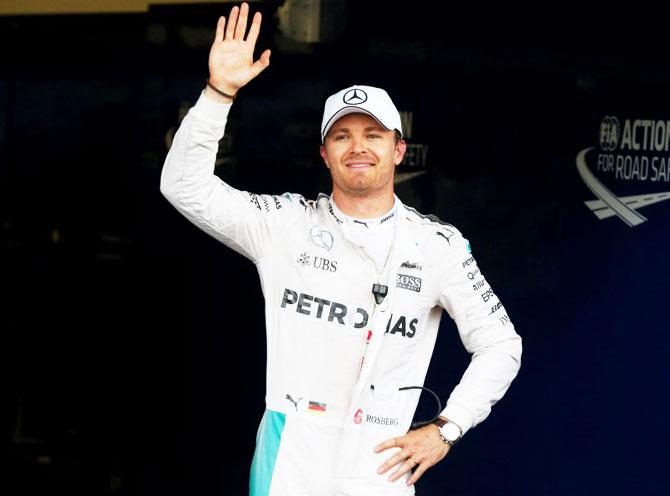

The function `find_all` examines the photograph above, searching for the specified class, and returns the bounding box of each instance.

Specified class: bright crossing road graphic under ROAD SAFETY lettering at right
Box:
[576,147,670,227]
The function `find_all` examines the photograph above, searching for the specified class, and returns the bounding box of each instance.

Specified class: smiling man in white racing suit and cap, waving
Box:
[161,4,521,496]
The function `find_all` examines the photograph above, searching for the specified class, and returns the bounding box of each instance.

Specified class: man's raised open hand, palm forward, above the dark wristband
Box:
[207,2,270,101]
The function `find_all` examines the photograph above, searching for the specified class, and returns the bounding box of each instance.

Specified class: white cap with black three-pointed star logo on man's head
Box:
[321,85,402,143]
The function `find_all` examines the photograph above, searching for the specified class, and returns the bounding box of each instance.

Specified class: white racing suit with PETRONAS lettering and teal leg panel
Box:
[161,95,521,496]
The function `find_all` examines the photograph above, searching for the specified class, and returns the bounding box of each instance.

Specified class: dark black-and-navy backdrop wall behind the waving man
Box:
[5,0,670,495]
